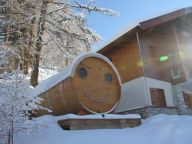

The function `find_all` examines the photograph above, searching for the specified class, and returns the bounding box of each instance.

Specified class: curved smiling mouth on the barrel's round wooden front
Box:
[82,90,111,103]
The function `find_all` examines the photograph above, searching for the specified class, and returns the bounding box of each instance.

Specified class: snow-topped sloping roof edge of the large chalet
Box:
[97,7,192,52]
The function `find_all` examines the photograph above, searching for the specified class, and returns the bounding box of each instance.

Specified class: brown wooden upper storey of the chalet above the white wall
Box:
[98,8,192,85]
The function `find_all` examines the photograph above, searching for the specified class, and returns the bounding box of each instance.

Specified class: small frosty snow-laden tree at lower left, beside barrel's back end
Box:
[0,71,42,144]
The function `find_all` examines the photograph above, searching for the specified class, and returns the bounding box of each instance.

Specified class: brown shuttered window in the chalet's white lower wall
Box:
[150,88,166,106]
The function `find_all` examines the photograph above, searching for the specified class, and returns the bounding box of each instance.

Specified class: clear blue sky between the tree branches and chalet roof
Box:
[87,0,192,50]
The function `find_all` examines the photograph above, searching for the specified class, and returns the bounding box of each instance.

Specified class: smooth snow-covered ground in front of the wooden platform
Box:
[17,115,192,144]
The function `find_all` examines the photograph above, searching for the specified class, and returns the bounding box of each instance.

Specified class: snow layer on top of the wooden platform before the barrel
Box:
[57,114,141,120]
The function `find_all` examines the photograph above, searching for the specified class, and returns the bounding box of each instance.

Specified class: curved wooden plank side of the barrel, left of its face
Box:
[36,78,81,116]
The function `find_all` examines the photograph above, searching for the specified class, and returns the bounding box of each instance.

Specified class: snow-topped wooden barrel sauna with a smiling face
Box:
[35,53,121,116]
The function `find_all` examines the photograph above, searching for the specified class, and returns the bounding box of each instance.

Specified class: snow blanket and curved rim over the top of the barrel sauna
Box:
[32,52,121,96]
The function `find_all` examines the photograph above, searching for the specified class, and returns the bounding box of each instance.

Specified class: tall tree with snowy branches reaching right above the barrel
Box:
[31,0,117,86]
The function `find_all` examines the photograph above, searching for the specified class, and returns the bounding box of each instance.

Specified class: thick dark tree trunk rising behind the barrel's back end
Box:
[31,0,48,86]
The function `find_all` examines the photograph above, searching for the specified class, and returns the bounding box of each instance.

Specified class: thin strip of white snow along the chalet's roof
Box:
[97,7,192,51]
